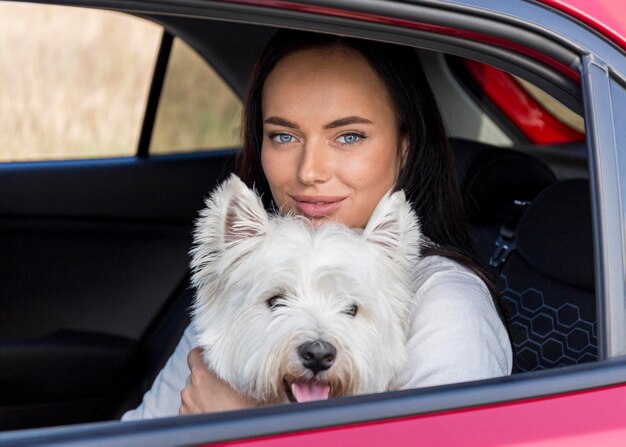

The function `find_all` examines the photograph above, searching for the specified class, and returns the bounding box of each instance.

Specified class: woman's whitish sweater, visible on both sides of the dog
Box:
[122,256,512,420]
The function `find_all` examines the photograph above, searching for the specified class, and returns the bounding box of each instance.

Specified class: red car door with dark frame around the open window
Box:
[0,0,626,445]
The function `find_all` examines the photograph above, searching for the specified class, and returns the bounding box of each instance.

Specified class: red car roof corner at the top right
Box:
[539,0,626,49]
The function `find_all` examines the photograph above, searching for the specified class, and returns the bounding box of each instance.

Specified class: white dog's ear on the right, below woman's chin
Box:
[363,190,422,262]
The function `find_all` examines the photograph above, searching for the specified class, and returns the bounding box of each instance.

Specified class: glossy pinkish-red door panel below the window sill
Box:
[211,385,626,447]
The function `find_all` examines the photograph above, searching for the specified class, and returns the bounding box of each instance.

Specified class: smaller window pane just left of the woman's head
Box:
[150,39,241,154]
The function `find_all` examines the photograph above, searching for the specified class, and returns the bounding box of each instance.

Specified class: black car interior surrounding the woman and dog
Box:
[0,1,598,429]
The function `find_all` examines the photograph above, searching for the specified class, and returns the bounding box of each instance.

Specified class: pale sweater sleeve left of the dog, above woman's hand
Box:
[122,325,196,421]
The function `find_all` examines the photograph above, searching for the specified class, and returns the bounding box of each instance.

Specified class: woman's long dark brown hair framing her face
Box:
[236,30,504,319]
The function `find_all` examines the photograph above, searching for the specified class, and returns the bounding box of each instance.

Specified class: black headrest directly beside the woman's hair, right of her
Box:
[450,139,556,220]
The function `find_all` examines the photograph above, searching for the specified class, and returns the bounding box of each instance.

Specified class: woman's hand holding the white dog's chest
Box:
[178,348,253,416]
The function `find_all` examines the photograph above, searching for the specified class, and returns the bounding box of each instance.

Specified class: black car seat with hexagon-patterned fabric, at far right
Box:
[497,179,598,372]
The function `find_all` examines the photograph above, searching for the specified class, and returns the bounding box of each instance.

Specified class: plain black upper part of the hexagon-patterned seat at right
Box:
[515,179,595,291]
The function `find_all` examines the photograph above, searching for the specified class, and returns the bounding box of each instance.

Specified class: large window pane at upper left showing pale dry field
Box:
[0,2,162,162]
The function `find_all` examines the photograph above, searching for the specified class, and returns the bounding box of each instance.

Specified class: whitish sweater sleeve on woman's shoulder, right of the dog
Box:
[397,258,512,389]
